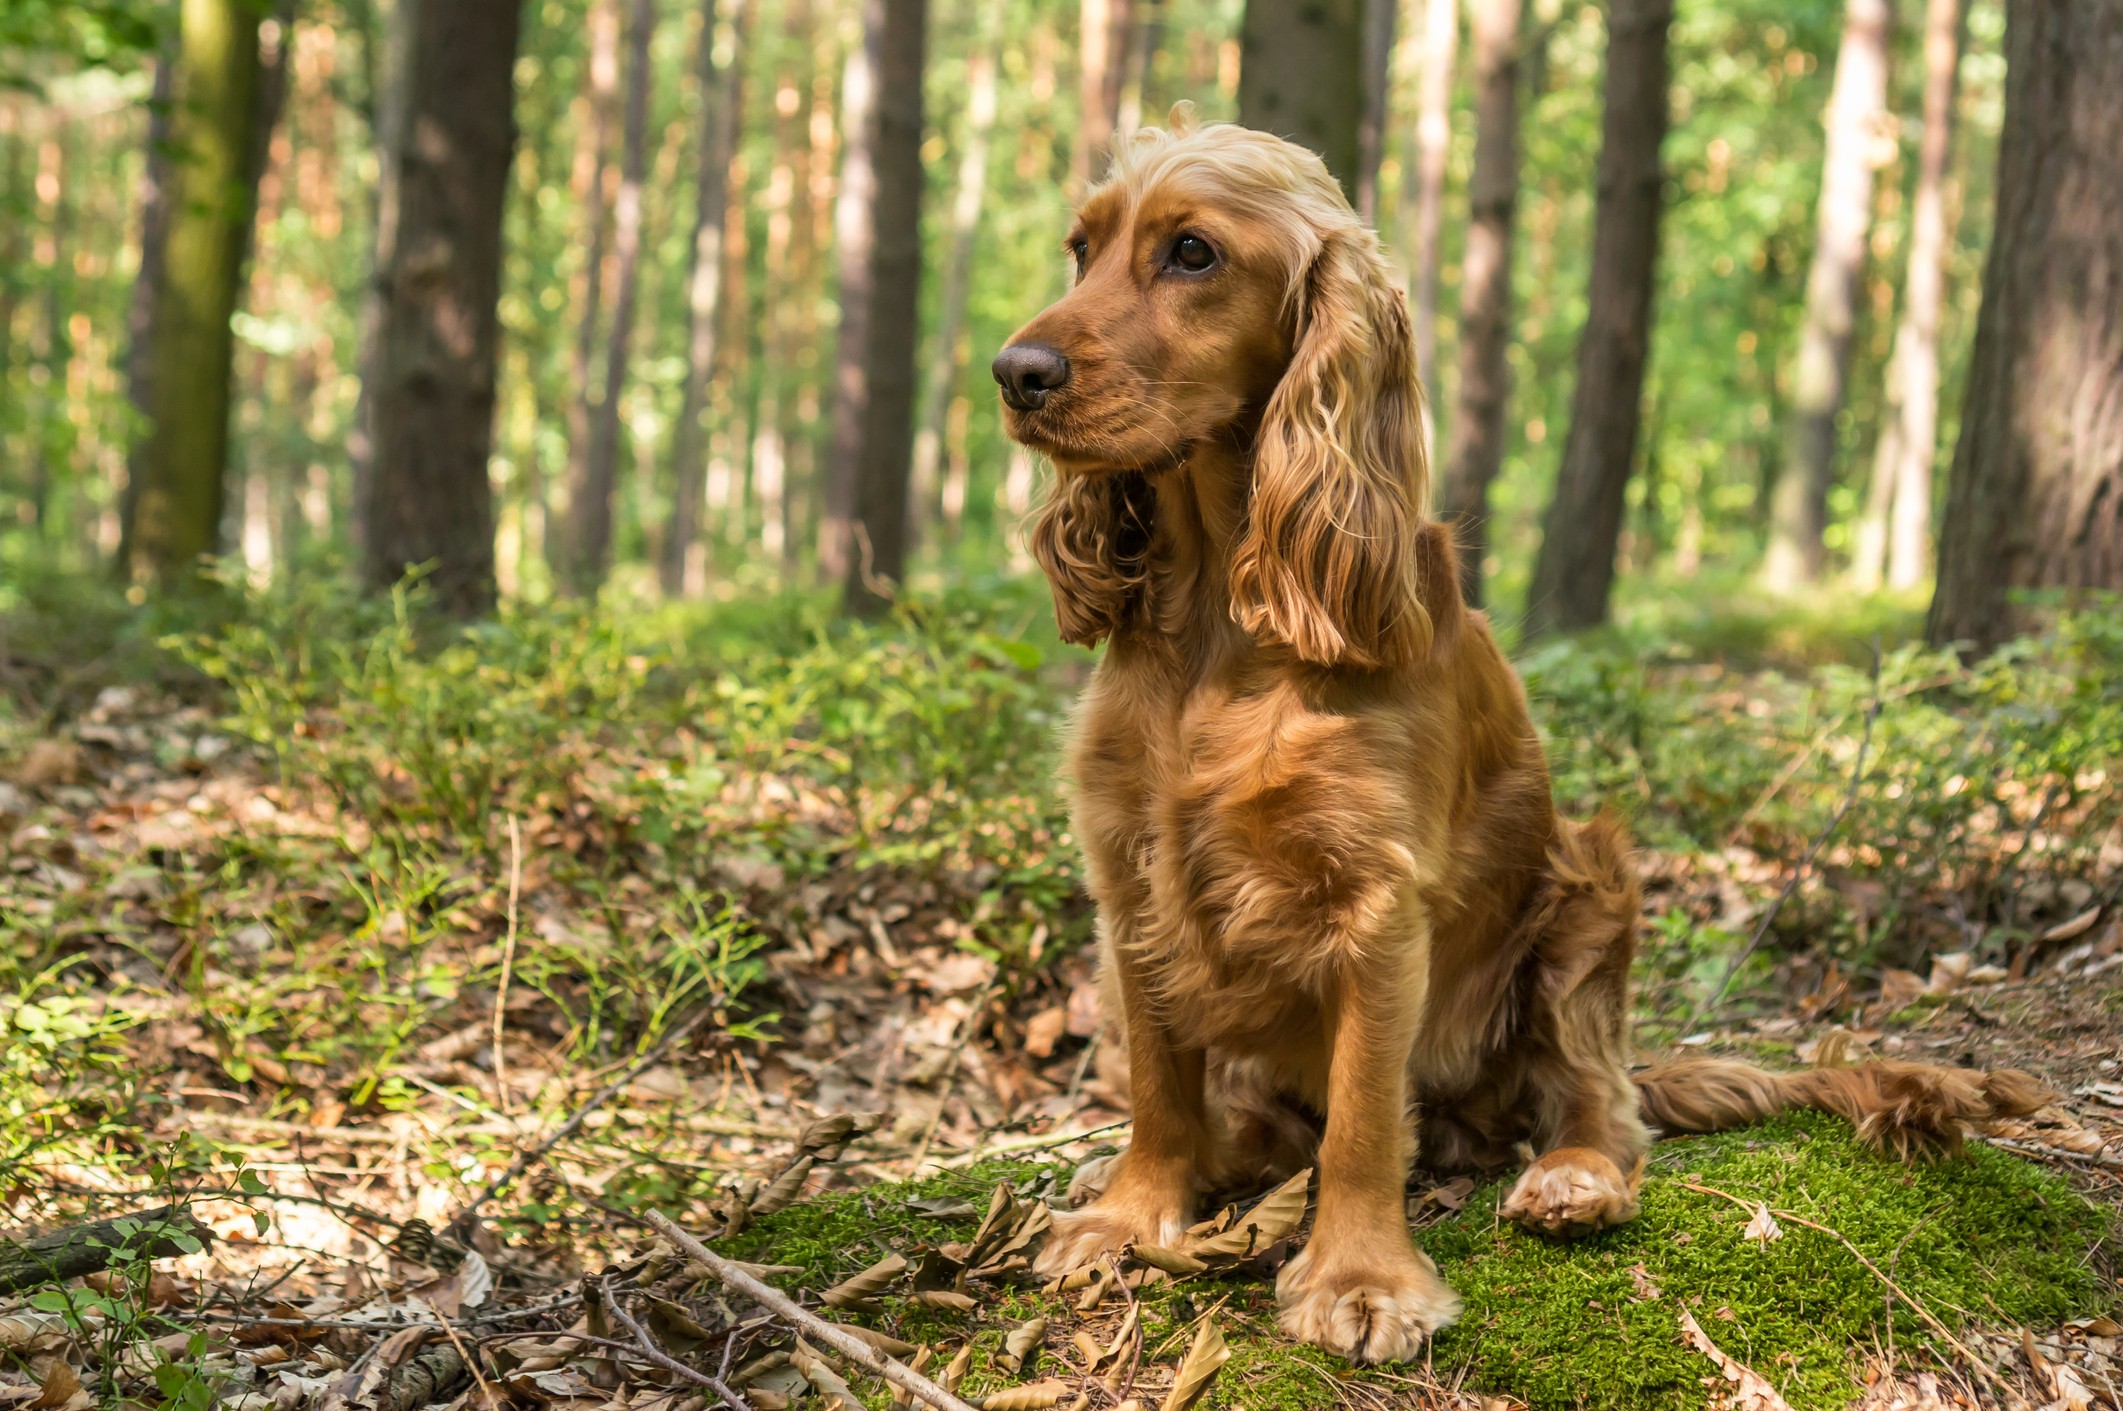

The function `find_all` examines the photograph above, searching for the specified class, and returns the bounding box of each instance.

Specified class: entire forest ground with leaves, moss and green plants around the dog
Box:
[0,564,2123,1411]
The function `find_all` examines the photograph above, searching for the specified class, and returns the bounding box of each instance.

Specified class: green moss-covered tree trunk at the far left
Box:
[132,0,259,586]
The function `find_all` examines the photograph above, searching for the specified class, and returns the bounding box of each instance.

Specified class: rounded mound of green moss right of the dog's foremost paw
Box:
[1422,1114,2106,1411]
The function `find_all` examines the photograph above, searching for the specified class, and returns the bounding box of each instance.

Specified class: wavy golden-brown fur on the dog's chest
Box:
[1070,658,1420,1052]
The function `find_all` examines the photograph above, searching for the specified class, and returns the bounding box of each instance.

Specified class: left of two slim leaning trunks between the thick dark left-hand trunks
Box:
[569,0,656,596]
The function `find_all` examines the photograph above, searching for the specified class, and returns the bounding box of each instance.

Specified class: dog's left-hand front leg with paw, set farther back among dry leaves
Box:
[1036,925,1210,1275]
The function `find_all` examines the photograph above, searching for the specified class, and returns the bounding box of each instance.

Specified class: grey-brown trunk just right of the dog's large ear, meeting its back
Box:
[1437,0,1520,607]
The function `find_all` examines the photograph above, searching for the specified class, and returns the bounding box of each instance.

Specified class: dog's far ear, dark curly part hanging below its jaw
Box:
[1032,471,1151,647]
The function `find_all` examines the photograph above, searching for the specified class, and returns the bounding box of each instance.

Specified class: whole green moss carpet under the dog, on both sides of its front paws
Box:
[692,1114,2108,1411]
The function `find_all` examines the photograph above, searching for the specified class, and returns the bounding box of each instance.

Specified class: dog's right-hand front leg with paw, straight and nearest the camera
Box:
[1276,920,1461,1362]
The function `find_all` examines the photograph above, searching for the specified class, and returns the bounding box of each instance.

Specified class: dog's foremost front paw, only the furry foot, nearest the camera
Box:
[1276,1235,1461,1362]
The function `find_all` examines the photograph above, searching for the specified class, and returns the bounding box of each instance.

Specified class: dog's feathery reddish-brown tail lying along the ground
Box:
[1633,1059,2055,1161]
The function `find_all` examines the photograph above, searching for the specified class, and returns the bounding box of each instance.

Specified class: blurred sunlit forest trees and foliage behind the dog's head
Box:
[0,0,2123,641]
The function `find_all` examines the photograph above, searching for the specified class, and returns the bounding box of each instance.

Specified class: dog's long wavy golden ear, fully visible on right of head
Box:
[1231,227,1431,666]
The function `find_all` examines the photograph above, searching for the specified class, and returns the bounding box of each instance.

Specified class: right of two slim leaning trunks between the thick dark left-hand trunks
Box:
[662,0,749,598]
